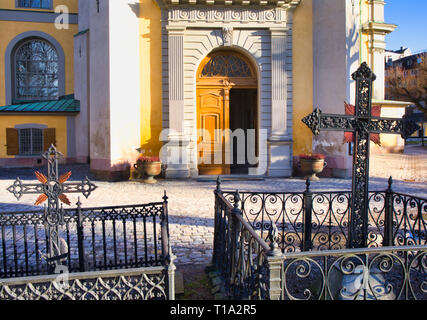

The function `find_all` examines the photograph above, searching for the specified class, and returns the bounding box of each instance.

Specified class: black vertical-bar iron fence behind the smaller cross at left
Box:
[0,197,169,278]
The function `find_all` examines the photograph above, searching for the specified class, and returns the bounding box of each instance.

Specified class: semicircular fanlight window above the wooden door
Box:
[201,55,252,77]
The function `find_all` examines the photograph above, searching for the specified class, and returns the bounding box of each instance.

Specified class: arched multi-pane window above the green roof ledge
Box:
[13,38,59,102]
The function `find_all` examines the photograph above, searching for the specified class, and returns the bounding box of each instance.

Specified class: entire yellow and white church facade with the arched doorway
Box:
[0,0,395,180]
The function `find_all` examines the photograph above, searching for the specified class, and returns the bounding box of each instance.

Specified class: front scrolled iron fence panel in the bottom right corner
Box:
[281,246,427,300]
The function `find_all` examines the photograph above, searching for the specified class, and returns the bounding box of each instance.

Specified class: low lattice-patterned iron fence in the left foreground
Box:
[0,267,173,300]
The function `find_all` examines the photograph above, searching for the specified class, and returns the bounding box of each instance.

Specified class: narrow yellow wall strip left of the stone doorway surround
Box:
[139,0,163,156]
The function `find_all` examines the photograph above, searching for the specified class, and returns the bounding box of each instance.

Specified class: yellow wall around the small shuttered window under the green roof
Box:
[0,115,67,158]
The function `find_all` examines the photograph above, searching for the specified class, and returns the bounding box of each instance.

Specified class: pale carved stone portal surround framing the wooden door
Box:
[161,1,296,178]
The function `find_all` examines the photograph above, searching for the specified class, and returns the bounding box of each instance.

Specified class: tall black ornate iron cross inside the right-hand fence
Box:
[302,62,419,248]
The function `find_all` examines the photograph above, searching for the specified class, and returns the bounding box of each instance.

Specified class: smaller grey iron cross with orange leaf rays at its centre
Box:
[7,145,97,272]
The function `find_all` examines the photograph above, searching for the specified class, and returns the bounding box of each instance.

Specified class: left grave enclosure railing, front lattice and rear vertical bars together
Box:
[0,193,175,300]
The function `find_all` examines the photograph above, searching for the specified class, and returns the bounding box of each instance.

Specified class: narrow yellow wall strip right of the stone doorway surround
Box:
[292,0,313,156]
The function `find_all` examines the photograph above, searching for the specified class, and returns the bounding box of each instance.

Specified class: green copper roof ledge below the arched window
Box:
[0,95,80,114]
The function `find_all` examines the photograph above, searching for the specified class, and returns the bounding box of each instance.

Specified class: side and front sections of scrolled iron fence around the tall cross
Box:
[213,188,427,300]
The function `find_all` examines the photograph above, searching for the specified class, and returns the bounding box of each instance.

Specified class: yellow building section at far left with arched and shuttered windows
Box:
[0,0,80,167]
